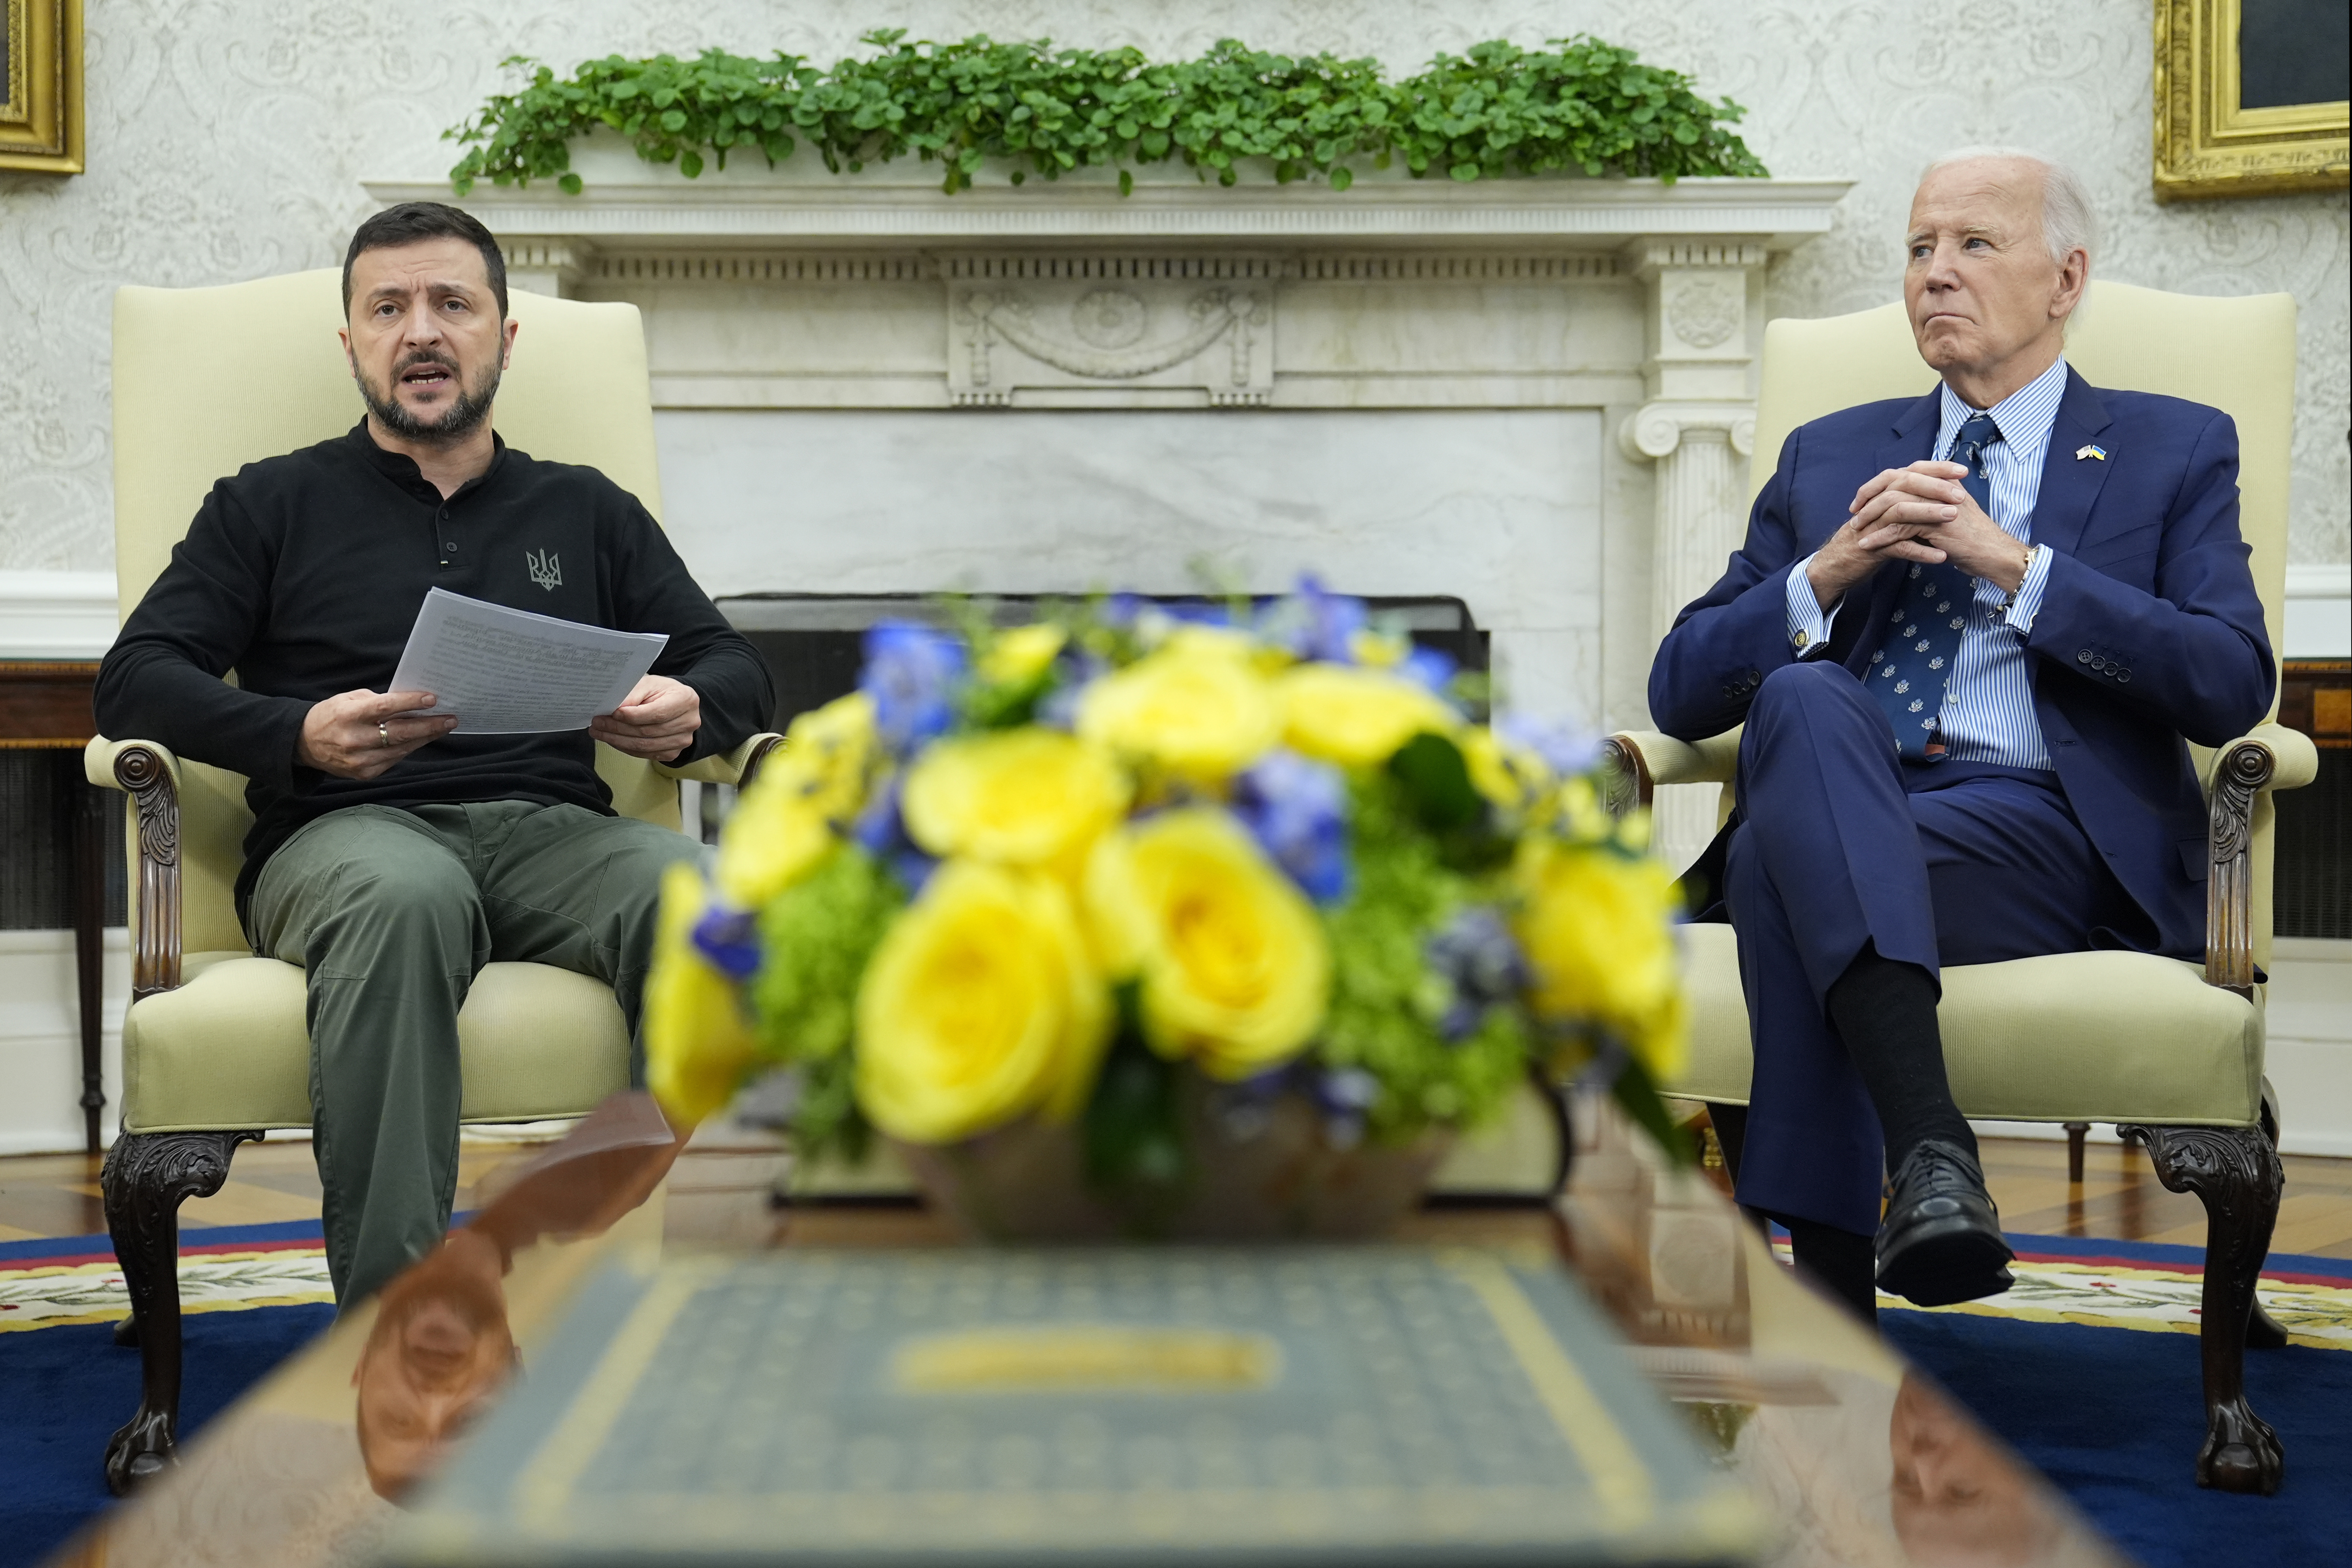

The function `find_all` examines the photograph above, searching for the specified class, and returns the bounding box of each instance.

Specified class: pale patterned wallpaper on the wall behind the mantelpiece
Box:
[0,0,2352,569]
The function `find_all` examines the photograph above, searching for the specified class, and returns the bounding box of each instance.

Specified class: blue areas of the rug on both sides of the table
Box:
[0,1222,2352,1568]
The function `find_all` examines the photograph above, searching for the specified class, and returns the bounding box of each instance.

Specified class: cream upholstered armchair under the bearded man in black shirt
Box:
[87,270,776,1493]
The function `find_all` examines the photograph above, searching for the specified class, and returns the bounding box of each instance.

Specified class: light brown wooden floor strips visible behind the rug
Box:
[0,1138,2352,1258]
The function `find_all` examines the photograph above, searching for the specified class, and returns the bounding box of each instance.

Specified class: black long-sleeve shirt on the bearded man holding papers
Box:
[96,423,774,912]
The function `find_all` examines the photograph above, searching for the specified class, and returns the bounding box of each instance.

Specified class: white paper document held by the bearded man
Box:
[390,588,670,736]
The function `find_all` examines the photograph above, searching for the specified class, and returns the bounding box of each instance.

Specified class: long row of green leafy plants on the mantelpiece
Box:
[442,30,1764,195]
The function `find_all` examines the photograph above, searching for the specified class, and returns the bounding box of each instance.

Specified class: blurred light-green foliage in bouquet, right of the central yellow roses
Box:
[1317,774,1531,1143]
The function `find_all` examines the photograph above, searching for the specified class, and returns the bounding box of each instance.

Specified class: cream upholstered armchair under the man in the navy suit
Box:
[1611,282,2319,1493]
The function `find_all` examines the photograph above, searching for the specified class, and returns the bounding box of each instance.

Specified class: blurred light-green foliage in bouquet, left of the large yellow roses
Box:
[750,844,906,1159]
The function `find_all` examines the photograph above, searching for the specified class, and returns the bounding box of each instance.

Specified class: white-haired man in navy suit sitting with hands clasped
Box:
[1649,150,2274,1317]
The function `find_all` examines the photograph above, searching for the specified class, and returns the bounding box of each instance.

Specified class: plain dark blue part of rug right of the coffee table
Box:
[1879,1316,2352,1568]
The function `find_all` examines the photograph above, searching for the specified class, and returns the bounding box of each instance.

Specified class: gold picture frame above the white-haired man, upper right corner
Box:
[2154,0,2347,202]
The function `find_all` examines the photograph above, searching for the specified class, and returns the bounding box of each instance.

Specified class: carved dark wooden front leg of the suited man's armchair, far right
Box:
[2114,1126,2286,1495]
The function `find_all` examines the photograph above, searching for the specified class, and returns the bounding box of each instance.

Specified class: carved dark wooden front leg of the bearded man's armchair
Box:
[99,1133,261,1497]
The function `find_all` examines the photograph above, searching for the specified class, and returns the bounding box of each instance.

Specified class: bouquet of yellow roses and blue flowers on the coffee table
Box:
[647,581,1684,1239]
